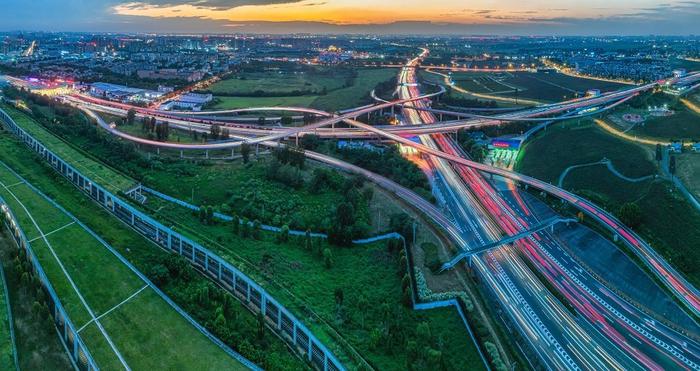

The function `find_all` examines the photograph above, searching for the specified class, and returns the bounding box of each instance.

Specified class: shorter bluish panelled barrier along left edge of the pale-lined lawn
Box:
[0,197,99,371]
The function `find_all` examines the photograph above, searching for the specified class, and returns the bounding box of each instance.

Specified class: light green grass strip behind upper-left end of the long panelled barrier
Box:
[0,104,136,193]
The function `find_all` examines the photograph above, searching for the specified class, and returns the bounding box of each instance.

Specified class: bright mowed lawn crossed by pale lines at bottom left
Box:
[0,164,243,370]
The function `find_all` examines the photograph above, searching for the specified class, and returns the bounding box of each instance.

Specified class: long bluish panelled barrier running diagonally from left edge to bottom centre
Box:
[0,109,345,371]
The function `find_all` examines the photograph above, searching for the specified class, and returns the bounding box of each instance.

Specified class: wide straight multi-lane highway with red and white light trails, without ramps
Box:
[400,51,700,369]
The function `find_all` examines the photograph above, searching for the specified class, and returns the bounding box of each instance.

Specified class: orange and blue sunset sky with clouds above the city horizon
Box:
[0,0,700,34]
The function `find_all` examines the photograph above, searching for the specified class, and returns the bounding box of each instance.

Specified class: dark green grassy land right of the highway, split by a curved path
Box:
[516,122,700,285]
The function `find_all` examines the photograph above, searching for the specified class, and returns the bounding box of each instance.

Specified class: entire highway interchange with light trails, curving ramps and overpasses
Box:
[57,50,700,370]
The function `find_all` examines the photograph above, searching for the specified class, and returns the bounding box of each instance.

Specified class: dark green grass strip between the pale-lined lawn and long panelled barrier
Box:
[0,131,304,370]
